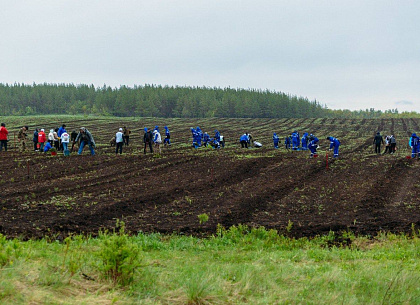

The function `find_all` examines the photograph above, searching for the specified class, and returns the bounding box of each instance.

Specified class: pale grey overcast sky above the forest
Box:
[0,0,420,111]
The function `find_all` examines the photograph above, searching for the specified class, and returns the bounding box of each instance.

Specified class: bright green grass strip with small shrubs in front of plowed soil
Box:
[0,226,420,304]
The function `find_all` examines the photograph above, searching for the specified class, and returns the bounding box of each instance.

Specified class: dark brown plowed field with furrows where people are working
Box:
[0,117,420,239]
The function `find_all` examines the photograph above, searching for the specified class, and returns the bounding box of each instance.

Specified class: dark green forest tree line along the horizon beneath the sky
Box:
[0,83,417,118]
